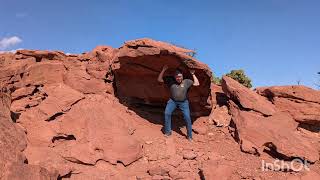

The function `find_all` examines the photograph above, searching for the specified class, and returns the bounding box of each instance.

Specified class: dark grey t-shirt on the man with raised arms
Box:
[163,76,193,101]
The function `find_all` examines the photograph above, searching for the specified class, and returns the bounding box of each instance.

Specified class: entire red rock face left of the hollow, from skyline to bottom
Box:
[0,46,142,179]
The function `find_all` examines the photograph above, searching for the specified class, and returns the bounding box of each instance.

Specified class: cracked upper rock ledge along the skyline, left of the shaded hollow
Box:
[0,46,116,94]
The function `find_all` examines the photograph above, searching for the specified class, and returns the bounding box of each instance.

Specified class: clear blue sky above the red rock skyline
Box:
[0,0,320,87]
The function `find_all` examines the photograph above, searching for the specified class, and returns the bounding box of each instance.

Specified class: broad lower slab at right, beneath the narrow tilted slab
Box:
[231,104,319,163]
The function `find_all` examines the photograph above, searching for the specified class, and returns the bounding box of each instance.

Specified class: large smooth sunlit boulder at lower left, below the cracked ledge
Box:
[19,93,142,174]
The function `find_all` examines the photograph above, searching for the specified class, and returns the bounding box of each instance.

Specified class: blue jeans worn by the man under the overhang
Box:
[164,99,192,138]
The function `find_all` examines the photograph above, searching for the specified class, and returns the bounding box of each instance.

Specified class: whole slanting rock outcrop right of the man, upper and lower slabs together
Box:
[222,79,319,163]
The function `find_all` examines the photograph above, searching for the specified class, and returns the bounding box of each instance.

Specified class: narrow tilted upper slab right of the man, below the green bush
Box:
[222,76,276,116]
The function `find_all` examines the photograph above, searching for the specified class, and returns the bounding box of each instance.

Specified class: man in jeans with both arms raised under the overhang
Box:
[158,65,200,141]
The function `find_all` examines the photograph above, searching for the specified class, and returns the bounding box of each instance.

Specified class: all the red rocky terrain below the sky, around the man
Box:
[0,39,320,180]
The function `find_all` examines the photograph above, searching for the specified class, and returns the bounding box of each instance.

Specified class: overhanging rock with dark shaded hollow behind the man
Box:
[114,39,211,115]
